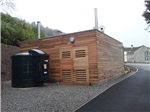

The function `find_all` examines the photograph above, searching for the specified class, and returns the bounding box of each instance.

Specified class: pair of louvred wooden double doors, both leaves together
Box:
[60,46,89,85]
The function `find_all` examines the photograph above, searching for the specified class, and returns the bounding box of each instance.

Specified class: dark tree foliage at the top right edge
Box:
[142,0,150,24]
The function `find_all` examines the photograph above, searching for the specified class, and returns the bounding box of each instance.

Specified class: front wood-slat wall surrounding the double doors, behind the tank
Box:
[20,30,99,82]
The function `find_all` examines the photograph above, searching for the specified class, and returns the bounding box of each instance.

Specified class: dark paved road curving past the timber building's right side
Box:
[76,64,150,112]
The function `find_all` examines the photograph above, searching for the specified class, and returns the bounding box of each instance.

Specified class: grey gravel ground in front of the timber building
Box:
[1,73,134,112]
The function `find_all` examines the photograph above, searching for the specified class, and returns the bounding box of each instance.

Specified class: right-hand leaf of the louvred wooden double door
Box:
[73,46,89,85]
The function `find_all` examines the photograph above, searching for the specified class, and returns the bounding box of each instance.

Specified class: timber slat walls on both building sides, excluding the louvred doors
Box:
[20,30,124,82]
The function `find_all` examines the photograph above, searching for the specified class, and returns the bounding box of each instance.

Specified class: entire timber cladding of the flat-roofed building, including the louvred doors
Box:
[20,29,124,85]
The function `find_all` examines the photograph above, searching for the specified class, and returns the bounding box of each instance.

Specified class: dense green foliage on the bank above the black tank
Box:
[0,13,45,46]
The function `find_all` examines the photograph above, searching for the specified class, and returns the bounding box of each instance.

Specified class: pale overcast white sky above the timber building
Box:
[9,0,150,47]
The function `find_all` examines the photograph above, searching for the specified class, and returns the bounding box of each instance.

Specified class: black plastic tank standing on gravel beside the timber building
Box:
[11,49,49,88]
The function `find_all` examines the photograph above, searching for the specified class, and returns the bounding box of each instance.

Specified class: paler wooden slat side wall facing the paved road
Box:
[96,31,124,81]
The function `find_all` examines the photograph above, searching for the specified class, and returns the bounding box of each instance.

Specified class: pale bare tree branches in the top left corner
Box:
[0,0,15,13]
